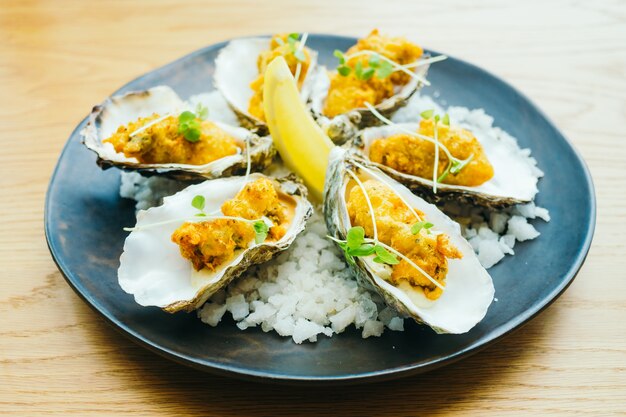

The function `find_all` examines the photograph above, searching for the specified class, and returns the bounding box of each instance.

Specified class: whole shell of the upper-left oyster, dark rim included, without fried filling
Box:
[81,86,276,180]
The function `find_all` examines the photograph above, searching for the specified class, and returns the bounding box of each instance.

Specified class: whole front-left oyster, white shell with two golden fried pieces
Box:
[118,173,313,313]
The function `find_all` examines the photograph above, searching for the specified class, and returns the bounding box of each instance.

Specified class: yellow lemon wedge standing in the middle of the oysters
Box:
[263,56,334,201]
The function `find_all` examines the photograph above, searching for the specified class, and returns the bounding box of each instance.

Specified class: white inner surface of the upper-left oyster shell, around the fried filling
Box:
[83,86,271,172]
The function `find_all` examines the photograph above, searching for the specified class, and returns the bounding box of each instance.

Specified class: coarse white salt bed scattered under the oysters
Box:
[120,92,550,343]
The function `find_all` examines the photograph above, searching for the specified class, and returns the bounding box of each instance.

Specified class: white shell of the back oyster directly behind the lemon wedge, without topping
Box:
[213,37,317,134]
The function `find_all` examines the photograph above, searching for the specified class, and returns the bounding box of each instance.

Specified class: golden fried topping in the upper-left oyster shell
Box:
[104,114,240,165]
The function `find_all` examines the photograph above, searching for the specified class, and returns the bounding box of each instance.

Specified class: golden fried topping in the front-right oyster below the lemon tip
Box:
[348,180,462,300]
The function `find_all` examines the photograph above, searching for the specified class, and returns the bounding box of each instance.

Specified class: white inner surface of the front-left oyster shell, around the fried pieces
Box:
[118,174,309,307]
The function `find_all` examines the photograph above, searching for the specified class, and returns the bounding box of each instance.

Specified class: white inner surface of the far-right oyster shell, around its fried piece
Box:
[360,123,538,201]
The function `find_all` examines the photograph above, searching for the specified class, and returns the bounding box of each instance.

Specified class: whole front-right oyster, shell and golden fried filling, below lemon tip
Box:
[324,148,494,333]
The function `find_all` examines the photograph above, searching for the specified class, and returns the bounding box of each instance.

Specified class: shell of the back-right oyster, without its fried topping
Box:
[309,62,429,145]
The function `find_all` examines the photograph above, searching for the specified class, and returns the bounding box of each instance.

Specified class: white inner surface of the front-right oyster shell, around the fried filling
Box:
[339,158,495,334]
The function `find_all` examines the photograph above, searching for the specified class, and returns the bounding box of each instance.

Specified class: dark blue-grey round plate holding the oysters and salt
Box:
[45,35,595,383]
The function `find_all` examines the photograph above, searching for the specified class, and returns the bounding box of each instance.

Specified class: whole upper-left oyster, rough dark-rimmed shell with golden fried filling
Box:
[81,86,276,180]
